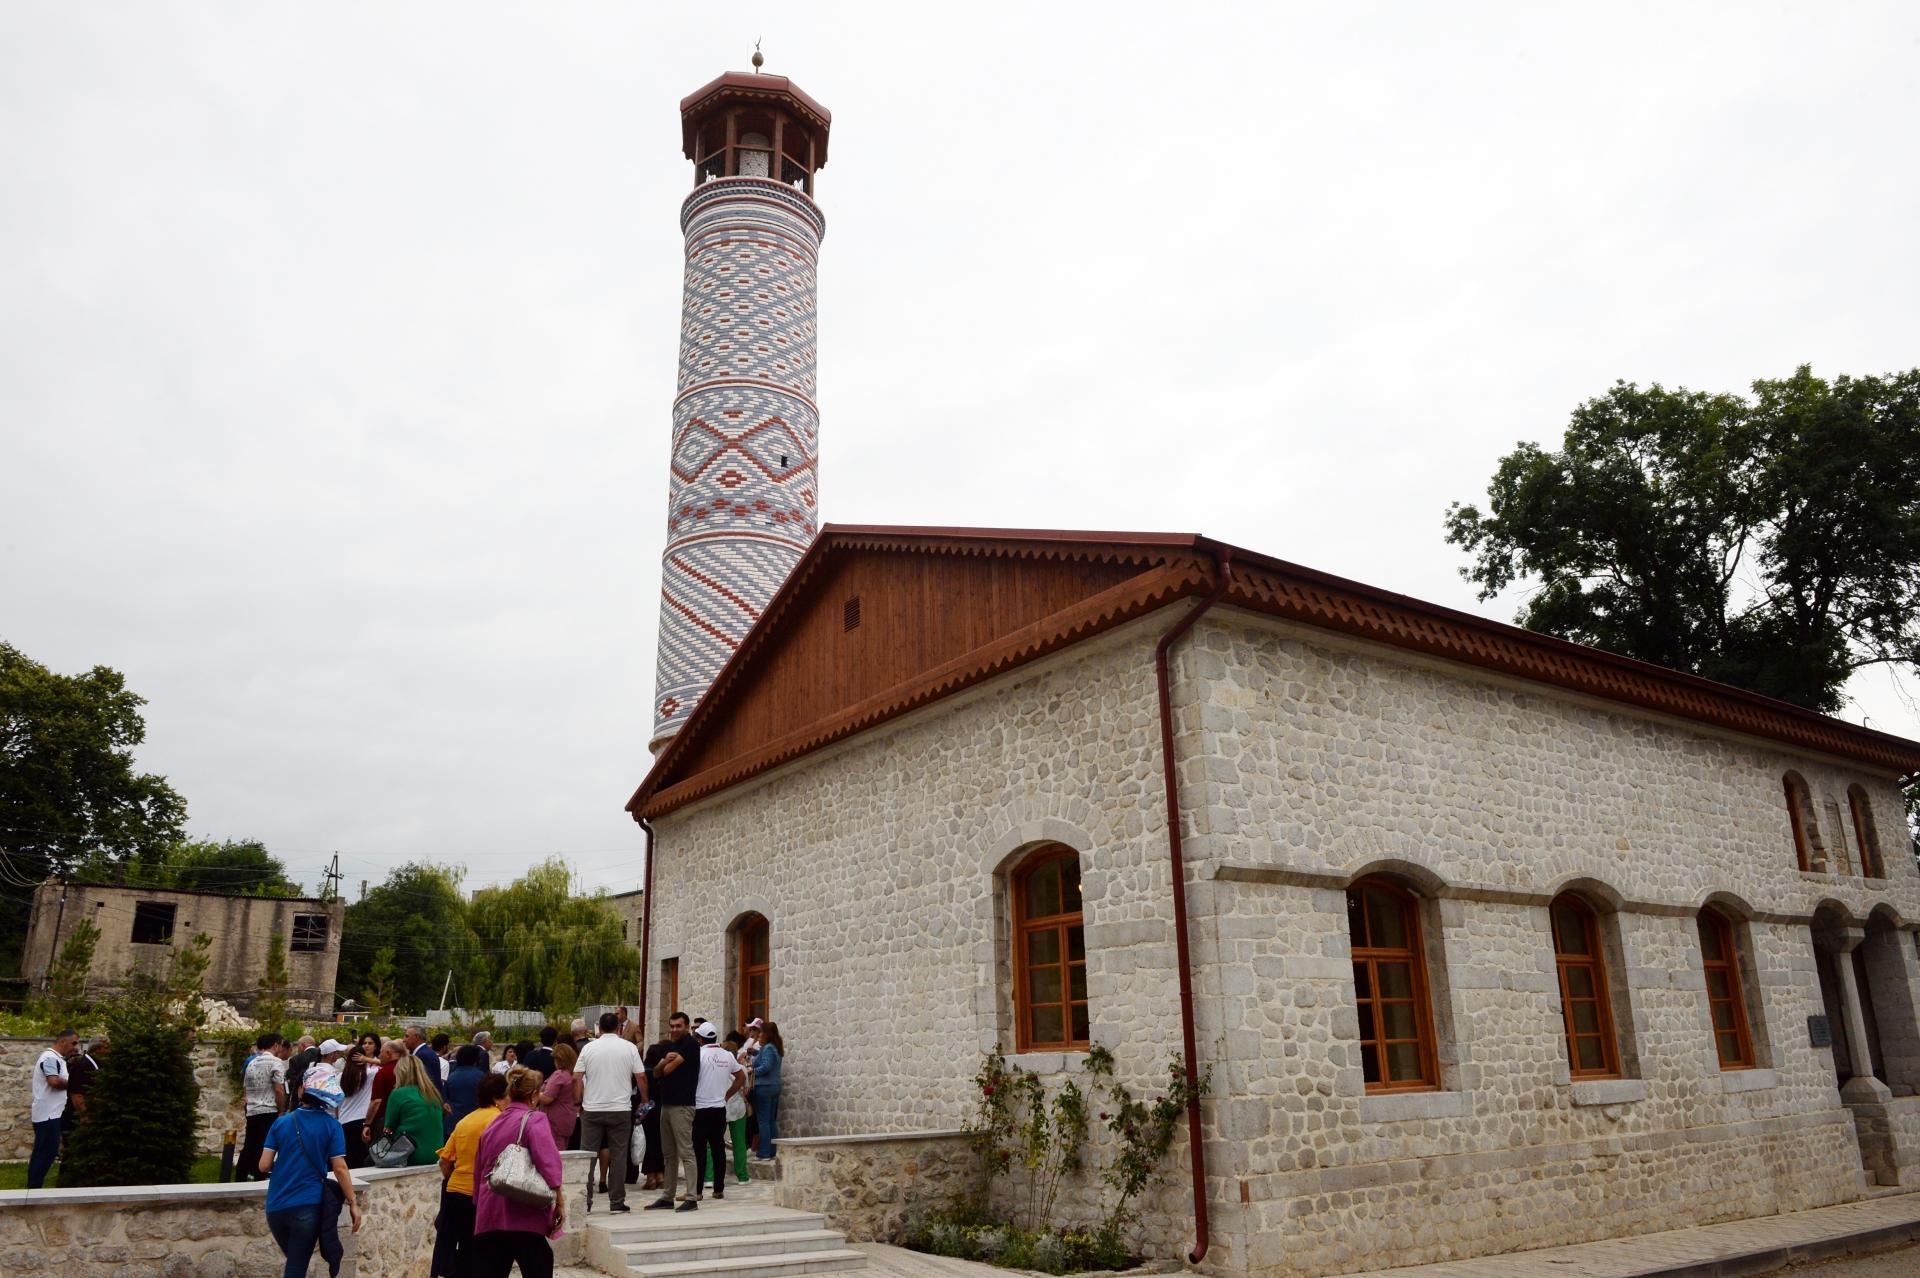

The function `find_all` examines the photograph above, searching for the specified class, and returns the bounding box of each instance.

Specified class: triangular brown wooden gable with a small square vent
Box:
[632,526,1210,816]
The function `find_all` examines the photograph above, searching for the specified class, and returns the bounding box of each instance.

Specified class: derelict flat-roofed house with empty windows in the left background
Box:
[21,881,346,1017]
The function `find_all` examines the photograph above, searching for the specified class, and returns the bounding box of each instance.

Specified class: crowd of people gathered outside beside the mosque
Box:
[176,1007,785,1278]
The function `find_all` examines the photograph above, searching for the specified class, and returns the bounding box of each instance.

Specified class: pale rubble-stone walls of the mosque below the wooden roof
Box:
[647,612,1920,1276]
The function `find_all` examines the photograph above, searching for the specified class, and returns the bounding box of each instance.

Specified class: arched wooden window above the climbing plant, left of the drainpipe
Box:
[1014,844,1089,1052]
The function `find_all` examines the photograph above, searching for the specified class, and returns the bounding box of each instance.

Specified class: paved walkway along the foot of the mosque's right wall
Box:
[1367,1194,1920,1278]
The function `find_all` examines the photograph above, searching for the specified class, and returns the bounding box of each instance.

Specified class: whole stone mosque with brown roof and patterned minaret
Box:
[628,64,1920,1278]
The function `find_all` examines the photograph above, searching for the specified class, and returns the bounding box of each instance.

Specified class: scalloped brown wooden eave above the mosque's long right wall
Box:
[1225,553,1920,773]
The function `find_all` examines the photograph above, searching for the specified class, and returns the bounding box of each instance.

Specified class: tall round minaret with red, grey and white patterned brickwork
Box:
[649,64,833,752]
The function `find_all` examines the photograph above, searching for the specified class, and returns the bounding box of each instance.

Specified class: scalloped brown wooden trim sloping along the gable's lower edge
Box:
[634,556,1212,819]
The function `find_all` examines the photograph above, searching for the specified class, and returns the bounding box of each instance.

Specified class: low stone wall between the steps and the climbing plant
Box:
[774,1130,979,1243]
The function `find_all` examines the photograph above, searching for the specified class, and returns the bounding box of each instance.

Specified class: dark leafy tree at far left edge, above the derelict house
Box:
[0,643,186,975]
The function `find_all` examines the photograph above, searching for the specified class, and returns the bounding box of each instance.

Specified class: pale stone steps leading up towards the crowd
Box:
[588,1195,866,1278]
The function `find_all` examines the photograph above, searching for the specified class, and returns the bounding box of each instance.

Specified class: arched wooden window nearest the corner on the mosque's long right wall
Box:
[1346,879,1440,1092]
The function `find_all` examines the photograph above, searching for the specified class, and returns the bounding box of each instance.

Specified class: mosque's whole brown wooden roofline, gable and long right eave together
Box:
[628,524,1920,817]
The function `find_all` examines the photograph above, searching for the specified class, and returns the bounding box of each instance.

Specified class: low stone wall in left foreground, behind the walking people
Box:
[0,1151,593,1278]
